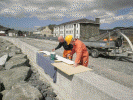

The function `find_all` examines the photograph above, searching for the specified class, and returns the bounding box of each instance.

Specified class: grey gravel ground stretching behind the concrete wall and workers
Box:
[20,38,133,88]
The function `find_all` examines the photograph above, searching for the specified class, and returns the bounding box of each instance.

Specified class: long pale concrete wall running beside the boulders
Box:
[0,37,133,100]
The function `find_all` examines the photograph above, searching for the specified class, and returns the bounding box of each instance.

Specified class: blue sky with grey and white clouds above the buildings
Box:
[0,0,133,31]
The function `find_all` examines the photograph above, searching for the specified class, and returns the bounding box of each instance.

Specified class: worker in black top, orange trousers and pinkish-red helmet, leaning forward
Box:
[52,36,73,60]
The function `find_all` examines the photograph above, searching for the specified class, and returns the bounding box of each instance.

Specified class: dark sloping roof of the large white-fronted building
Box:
[58,18,97,26]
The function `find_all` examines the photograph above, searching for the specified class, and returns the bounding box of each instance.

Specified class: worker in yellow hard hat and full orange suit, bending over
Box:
[65,35,89,67]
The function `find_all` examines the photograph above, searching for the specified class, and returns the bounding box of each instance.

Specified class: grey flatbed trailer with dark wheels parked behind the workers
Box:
[84,39,122,58]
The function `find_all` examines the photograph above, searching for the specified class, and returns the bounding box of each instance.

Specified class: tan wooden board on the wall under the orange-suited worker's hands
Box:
[52,62,92,75]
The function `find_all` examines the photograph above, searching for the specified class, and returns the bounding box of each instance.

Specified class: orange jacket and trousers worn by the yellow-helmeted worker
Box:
[70,39,89,67]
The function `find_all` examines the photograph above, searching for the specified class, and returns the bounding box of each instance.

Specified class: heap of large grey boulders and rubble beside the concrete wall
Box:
[0,39,58,100]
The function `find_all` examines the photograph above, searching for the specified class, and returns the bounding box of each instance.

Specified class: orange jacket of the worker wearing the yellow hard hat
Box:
[70,39,89,63]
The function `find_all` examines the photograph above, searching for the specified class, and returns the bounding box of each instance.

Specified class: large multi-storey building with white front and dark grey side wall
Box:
[53,18,100,39]
